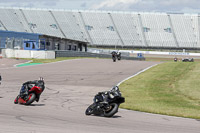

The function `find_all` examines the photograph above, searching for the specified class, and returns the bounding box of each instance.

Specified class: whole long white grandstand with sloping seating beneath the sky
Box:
[0,8,200,49]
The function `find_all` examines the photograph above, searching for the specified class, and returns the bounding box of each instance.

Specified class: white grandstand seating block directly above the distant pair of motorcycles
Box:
[78,12,122,46]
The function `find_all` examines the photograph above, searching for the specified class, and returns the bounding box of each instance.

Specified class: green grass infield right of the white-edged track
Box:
[120,62,200,119]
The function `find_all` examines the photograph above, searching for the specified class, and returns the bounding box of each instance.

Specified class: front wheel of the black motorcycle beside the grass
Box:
[104,103,119,117]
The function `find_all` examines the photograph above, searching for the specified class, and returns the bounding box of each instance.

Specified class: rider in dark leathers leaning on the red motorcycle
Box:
[14,77,45,104]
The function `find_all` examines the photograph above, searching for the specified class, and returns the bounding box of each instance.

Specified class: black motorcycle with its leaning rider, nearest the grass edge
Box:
[85,86,125,117]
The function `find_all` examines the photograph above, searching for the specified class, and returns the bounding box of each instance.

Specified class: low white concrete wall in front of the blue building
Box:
[2,49,55,59]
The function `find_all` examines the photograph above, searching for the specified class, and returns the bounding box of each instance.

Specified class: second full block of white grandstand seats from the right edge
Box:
[141,13,176,47]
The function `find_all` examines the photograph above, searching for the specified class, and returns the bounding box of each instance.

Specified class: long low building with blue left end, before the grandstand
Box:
[0,31,87,51]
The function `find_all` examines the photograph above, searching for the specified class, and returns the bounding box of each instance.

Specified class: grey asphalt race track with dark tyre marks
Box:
[0,59,200,133]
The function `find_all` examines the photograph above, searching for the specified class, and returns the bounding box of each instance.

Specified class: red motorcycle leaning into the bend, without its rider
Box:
[14,85,44,105]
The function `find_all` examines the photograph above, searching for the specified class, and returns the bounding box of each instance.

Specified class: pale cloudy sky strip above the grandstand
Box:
[0,0,200,13]
